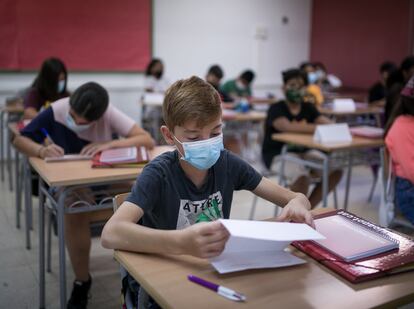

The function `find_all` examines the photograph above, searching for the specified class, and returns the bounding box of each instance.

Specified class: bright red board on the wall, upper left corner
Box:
[0,0,152,71]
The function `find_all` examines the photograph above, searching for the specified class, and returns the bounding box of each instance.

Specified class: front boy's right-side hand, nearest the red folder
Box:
[277,194,315,228]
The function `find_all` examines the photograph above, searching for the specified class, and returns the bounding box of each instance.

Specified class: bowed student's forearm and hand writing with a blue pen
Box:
[13,135,65,159]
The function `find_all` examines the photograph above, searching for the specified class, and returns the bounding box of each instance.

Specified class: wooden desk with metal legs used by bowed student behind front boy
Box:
[29,146,173,309]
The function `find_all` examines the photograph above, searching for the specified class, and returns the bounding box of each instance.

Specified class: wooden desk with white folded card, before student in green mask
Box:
[272,133,384,210]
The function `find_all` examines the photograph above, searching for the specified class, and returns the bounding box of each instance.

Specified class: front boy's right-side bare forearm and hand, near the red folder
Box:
[253,177,315,227]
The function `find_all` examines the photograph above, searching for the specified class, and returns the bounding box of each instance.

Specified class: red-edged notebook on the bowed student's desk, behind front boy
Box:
[92,146,149,167]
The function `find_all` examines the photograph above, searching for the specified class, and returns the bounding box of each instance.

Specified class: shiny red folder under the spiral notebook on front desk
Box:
[292,210,414,283]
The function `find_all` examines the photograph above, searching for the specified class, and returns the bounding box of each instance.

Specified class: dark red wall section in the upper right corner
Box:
[310,0,413,88]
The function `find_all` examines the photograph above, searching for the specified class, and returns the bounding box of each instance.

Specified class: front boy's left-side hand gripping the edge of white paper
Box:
[181,221,229,258]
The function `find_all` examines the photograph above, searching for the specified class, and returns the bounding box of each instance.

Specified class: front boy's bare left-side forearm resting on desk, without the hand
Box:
[101,222,185,254]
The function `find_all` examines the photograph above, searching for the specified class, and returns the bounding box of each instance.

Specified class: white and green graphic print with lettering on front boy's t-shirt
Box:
[177,191,223,230]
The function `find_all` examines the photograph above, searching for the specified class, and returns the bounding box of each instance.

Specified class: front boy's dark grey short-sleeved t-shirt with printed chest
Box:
[127,150,262,230]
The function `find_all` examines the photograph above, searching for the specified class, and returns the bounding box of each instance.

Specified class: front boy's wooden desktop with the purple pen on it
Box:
[115,210,414,309]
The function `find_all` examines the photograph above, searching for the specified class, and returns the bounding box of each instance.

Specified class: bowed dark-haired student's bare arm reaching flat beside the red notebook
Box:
[81,124,155,156]
